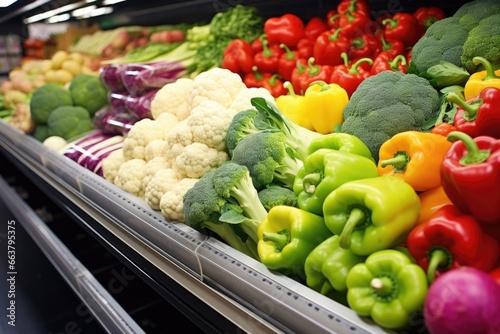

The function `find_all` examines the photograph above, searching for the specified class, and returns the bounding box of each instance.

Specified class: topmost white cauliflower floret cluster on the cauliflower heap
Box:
[188,67,246,110]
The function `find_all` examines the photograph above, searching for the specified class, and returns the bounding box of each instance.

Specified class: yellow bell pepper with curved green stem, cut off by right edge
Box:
[464,57,500,100]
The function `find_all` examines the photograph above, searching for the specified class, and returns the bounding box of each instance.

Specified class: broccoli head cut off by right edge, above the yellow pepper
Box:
[461,13,500,73]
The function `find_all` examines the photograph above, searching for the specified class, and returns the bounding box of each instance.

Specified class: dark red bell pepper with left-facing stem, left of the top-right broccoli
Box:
[382,13,421,47]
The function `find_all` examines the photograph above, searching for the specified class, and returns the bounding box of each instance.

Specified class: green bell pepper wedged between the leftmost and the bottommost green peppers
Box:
[304,235,366,300]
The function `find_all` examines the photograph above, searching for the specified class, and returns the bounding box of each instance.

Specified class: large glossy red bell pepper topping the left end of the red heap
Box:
[264,14,305,47]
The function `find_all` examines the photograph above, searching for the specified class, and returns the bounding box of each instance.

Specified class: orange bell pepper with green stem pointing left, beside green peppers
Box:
[377,131,451,191]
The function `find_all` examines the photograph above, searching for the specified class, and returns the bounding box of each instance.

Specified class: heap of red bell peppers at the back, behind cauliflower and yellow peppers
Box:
[222,0,445,97]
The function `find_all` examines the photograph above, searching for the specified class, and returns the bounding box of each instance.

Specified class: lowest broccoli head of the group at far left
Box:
[47,106,94,140]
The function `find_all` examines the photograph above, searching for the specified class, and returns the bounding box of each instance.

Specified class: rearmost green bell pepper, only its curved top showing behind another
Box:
[307,132,375,163]
